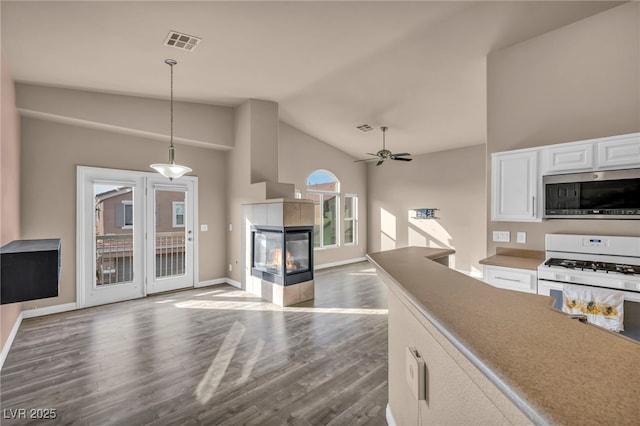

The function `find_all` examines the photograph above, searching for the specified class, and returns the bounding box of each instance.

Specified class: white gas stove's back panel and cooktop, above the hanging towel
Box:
[538,234,640,302]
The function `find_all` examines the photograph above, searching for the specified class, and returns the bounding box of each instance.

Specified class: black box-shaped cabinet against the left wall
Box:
[0,239,60,305]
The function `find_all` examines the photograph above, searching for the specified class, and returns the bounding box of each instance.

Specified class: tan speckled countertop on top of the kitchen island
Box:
[367,247,640,425]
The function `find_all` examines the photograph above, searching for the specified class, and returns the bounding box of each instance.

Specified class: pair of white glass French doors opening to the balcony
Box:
[76,167,197,307]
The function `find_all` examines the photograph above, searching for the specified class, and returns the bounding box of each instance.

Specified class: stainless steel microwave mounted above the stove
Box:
[542,169,640,219]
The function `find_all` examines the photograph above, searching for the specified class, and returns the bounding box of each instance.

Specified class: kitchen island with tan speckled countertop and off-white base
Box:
[367,247,640,425]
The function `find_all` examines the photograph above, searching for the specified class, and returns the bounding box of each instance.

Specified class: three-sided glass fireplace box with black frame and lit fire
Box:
[251,226,313,286]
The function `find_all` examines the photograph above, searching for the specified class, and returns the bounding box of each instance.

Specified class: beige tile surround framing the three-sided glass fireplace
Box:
[242,199,314,306]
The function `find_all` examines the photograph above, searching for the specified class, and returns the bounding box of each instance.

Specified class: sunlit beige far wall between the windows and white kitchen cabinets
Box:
[368,144,486,272]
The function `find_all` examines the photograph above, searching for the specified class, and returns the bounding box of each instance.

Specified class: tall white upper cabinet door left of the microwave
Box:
[491,151,540,222]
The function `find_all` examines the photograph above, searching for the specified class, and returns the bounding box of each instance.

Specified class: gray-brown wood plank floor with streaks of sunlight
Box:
[0,262,387,425]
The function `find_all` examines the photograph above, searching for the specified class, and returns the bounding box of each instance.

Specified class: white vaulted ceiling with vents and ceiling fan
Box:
[1,0,620,157]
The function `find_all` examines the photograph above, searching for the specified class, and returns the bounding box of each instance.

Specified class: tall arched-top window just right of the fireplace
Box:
[307,170,340,248]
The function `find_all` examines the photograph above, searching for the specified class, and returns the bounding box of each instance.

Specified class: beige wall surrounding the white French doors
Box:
[21,118,226,309]
